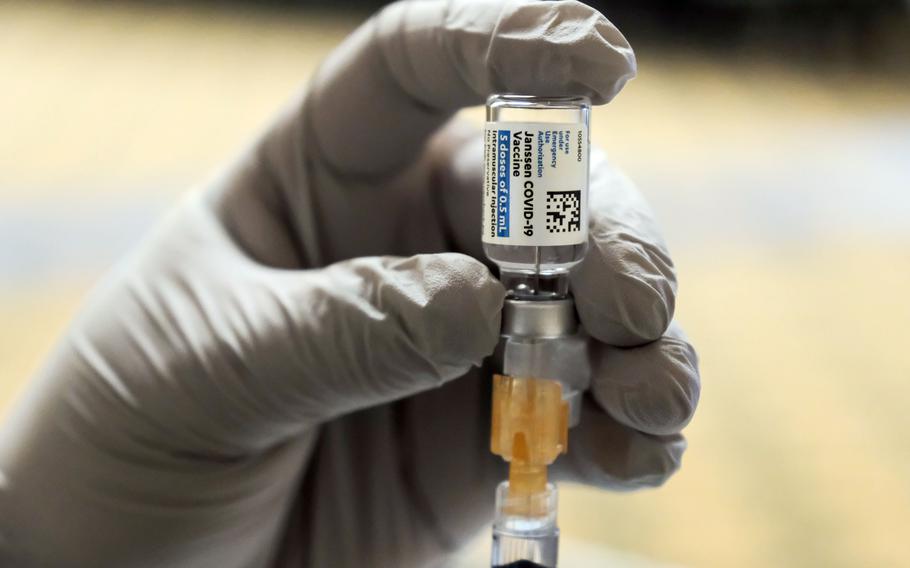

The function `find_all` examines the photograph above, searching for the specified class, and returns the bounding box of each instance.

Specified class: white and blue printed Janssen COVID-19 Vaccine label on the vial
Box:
[483,122,588,246]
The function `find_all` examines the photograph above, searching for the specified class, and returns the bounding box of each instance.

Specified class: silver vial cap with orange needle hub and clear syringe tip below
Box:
[490,298,590,568]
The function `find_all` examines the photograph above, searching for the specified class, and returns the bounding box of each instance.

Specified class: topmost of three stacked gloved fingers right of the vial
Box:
[571,151,676,346]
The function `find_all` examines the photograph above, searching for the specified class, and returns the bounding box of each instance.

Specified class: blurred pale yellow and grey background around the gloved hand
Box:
[0,0,910,568]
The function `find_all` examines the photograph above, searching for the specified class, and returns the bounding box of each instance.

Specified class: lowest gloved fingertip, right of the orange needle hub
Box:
[554,398,686,491]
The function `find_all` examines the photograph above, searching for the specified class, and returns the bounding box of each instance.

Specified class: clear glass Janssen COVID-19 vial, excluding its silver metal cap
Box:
[482,95,591,300]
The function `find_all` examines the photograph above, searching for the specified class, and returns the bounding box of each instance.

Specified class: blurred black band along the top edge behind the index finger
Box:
[114,0,910,77]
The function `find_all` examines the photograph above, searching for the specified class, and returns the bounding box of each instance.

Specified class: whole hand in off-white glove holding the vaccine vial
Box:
[0,0,699,568]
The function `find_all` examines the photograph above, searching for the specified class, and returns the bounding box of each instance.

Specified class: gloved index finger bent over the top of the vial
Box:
[306,0,635,175]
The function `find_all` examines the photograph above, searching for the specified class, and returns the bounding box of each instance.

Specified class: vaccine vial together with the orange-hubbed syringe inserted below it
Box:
[483,95,590,568]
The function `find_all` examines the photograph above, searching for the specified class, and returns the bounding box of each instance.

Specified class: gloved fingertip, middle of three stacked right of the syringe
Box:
[589,323,701,435]
